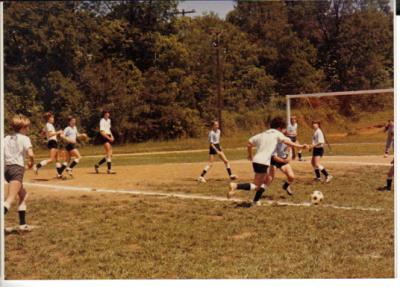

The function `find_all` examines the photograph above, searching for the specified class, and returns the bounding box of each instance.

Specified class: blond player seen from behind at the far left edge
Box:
[4,115,34,230]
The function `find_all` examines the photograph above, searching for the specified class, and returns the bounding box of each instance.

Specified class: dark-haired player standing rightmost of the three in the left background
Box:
[94,111,115,174]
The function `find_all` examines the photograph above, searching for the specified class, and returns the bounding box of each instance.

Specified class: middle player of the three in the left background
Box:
[61,116,83,177]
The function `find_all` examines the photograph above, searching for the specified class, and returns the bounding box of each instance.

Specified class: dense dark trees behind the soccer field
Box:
[5,0,393,143]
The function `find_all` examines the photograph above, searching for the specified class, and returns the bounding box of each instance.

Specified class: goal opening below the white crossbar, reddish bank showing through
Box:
[286,89,394,148]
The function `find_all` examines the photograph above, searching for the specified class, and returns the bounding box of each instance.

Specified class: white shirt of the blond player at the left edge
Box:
[4,133,32,167]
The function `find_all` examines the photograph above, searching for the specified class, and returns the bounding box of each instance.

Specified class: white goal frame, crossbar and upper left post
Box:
[286,88,394,123]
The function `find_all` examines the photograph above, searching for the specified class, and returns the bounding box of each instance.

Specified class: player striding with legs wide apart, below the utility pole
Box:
[197,121,237,182]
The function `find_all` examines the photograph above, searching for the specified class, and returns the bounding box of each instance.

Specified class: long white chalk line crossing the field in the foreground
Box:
[24,182,383,212]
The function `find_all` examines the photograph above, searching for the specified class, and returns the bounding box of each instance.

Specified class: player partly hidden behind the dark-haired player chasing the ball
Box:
[265,135,294,195]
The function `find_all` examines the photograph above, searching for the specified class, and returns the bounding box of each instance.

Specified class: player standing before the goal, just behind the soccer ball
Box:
[310,121,333,182]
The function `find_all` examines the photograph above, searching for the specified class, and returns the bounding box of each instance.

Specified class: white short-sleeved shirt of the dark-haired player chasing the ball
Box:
[249,129,287,165]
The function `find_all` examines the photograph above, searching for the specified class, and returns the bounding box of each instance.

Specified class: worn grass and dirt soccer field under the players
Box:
[6,137,394,280]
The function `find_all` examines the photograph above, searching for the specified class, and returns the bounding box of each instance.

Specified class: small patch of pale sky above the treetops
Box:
[178,0,235,19]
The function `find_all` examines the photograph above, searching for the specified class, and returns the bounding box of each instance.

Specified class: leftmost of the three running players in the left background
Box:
[33,112,62,178]
